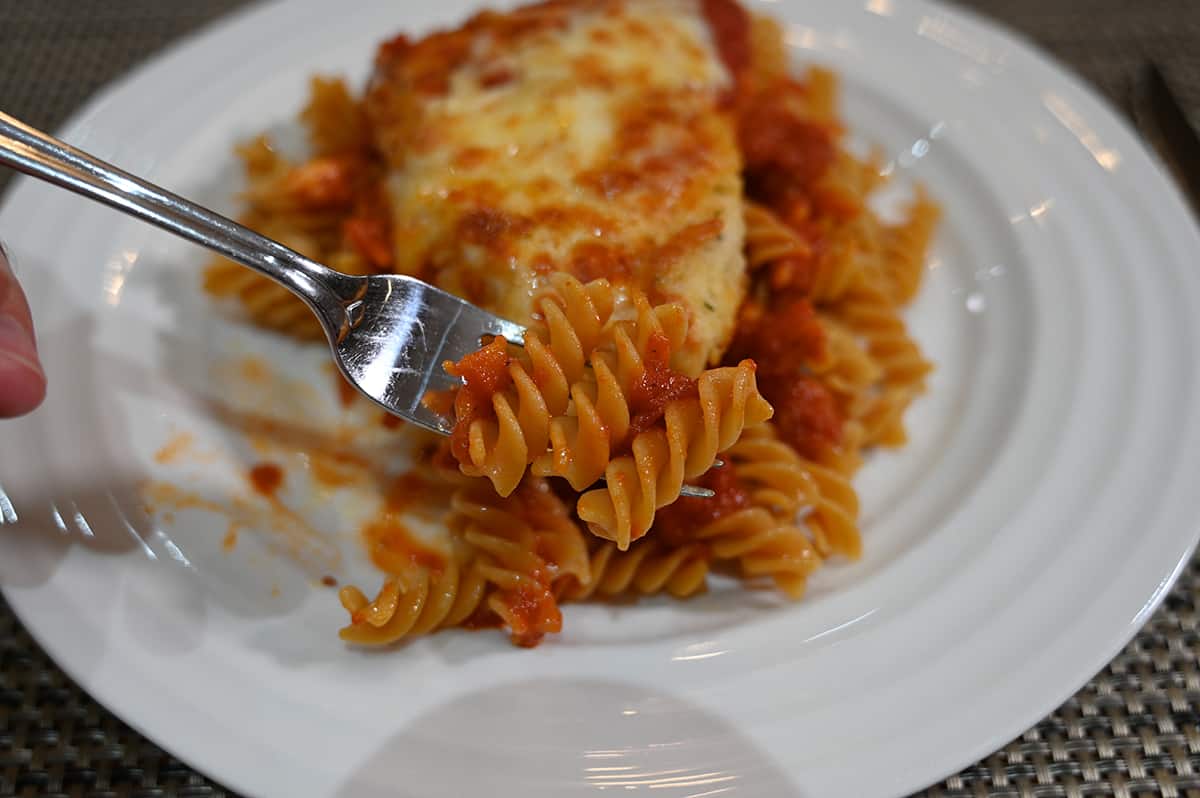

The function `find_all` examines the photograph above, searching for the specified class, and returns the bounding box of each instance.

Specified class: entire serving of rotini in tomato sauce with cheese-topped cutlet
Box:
[204,0,940,646]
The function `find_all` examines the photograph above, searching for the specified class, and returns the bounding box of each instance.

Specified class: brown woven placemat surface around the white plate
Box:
[0,0,1200,798]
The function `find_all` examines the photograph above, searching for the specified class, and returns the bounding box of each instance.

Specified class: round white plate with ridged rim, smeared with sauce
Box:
[0,0,1200,797]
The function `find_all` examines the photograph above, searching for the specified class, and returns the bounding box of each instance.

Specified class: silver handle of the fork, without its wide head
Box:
[0,112,344,312]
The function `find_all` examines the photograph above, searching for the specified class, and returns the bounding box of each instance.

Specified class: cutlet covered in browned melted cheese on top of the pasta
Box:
[367,0,745,372]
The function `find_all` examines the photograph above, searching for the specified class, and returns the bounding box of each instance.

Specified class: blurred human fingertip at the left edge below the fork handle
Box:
[0,248,46,419]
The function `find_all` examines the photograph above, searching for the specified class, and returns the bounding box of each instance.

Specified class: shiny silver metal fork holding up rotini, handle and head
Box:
[0,112,713,498]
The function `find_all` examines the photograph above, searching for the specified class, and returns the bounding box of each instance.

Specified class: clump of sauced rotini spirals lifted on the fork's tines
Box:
[446,275,770,537]
